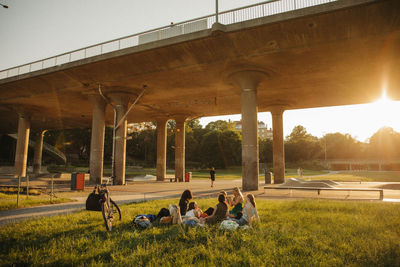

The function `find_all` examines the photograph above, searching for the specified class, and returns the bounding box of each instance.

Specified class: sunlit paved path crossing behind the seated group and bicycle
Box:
[0,179,400,225]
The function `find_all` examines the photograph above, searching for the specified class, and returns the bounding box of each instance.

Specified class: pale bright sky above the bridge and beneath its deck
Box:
[0,0,400,141]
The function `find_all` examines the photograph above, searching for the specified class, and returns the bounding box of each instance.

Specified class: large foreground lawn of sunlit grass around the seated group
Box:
[0,199,400,266]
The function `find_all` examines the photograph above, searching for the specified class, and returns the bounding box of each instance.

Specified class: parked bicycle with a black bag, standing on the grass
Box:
[86,184,121,231]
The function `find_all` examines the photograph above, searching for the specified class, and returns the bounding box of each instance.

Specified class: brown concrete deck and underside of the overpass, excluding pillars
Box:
[0,1,400,132]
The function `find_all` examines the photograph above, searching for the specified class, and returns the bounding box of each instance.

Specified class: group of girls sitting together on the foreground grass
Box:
[157,187,259,226]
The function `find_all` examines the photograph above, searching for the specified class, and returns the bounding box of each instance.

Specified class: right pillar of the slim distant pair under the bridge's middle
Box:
[175,117,186,182]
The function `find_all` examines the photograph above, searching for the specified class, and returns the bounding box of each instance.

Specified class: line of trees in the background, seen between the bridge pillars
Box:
[36,119,400,168]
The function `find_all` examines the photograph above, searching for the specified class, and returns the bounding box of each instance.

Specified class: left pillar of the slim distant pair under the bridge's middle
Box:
[157,119,168,181]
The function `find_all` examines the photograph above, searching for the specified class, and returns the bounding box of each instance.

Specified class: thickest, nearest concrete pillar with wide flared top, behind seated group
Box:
[230,71,265,190]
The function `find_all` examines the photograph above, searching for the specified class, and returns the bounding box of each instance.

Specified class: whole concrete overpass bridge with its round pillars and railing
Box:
[0,0,400,190]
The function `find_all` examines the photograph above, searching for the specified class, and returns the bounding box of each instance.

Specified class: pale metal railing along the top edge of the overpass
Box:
[0,0,337,79]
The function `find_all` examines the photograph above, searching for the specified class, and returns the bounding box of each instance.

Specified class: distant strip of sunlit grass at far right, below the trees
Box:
[313,171,400,182]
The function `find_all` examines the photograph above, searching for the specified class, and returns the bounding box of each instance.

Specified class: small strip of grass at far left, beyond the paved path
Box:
[0,193,74,210]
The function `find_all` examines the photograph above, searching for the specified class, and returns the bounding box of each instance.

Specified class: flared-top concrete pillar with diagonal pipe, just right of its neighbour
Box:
[110,93,131,185]
